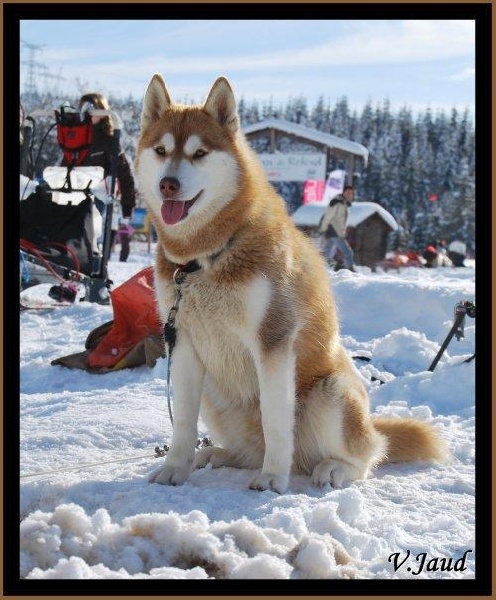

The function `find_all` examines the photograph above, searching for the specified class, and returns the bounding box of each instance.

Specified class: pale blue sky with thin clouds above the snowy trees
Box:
[20,19,475,114]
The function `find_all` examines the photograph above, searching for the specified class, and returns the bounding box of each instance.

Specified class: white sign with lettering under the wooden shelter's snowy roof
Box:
[257,153,326,181]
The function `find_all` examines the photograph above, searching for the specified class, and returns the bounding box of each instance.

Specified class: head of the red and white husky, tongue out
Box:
[136,74,239,236]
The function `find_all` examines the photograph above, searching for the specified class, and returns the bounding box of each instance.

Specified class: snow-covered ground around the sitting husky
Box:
[14,242,476,593]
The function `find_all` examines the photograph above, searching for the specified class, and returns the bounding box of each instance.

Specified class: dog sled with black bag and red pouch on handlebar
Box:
[20,104,121,308]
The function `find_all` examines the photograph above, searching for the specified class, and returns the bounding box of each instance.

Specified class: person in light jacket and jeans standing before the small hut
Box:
[319,185,355,271]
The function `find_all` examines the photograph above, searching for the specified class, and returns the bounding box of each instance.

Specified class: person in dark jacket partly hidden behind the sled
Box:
[62,92,136,262]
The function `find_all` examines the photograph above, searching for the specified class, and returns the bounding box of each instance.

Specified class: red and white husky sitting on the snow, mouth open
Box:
[136,74,446,493]
